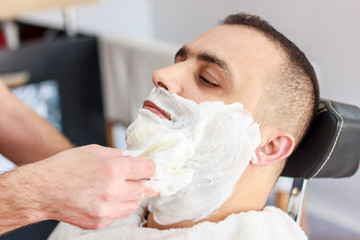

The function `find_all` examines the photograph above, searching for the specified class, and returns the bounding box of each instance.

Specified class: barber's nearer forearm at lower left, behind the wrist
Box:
[0,168,44,235]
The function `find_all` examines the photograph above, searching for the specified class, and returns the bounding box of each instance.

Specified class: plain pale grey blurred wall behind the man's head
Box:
[26,0,360,105]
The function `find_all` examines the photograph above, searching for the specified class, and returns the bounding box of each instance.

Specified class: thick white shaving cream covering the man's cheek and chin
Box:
[126,88,260,225]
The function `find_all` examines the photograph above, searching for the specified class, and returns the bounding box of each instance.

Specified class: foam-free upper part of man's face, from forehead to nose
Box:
[152,25,280,115]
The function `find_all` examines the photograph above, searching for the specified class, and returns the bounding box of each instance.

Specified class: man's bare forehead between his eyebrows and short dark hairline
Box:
[186,25,283,76]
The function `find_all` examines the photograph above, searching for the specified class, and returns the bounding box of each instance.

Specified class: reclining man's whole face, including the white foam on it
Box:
[127,26,280,225]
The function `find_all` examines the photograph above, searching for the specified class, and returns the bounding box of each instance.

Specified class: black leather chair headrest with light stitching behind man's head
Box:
[281,99,360,179]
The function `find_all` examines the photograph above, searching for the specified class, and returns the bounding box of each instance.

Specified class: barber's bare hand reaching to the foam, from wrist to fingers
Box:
[19,145,158,229]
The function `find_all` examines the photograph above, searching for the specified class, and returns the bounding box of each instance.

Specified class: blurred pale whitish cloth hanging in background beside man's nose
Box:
[99,36,179,125]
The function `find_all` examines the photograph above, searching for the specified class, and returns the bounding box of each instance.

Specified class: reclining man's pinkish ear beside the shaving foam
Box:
[255,130,295,166]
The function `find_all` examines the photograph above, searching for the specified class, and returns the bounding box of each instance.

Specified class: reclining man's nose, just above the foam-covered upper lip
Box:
[152,65,183,95]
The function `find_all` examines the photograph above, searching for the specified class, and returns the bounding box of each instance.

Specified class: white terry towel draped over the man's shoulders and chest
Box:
[49,204,307,240]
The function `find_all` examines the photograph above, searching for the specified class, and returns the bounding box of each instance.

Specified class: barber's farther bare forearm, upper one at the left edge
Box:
[0,79,72,165]
